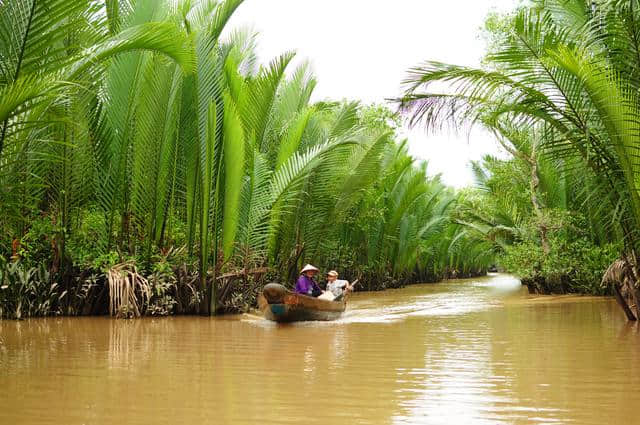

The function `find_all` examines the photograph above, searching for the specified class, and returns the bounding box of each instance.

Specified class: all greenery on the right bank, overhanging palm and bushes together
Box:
[402,0,640,316]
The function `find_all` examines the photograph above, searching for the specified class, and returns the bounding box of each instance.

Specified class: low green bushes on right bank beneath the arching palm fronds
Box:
[456,157,622,294]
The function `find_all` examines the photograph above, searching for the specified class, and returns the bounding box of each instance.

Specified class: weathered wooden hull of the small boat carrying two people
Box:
[258,283,347,322]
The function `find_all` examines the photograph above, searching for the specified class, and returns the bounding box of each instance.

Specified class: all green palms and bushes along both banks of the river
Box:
[12,0,640,318]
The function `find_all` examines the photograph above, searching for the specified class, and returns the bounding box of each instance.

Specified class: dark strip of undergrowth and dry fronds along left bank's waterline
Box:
[0,262,486,319]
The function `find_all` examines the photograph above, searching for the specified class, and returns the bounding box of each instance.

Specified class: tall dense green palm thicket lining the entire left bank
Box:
[0,0,494,318]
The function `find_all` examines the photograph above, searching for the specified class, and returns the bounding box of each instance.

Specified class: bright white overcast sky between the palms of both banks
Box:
[231,0,515,187]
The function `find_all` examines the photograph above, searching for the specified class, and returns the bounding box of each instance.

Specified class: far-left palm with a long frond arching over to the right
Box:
[0,0,192,264]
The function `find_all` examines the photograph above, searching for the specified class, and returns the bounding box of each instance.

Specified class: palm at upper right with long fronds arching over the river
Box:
[401,0,640,312]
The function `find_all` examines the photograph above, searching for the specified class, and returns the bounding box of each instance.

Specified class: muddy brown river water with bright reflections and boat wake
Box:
[0,275,640,424]
